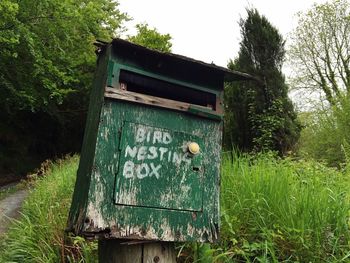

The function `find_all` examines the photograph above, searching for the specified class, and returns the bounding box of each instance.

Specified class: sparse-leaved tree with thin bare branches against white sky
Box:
[289,0,350,105]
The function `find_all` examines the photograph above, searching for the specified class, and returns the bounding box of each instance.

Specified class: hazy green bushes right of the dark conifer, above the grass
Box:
[299,96,350,167]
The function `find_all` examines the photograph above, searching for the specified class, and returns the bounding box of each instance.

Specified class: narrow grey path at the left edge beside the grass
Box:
[0,190,28,236]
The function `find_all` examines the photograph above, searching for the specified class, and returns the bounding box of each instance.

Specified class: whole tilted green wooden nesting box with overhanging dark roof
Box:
[68,39,248,242]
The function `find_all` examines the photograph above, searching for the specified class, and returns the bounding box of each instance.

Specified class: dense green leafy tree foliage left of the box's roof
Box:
[0,0,126,114]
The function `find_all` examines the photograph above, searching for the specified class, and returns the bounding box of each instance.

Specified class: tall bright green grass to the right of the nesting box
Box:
[217,155,350,262]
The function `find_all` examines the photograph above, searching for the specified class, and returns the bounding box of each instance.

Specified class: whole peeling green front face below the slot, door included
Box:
[83,100,221,241]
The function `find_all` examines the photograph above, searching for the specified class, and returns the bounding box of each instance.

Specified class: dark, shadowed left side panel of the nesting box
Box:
[68,47,110,234]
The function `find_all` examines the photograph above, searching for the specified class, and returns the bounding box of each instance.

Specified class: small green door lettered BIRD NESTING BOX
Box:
[116,122,206,211]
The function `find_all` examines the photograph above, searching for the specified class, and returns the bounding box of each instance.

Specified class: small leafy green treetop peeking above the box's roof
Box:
[128,23,172,52]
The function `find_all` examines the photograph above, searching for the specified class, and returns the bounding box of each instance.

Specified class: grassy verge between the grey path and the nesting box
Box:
[0,156,97,263]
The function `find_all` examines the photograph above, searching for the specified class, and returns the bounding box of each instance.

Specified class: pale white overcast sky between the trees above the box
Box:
[119,0,325,67]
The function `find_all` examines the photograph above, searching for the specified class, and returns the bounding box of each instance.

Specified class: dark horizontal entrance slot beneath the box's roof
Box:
[119,70,216,110]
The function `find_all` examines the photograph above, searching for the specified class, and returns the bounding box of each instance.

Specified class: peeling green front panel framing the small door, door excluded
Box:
[83,100,222,242]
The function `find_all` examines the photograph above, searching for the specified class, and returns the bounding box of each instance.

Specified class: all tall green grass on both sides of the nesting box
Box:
[0,154,350,263]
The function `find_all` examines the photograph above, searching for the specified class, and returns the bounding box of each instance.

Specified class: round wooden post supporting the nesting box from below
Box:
[98,239,176,263]
